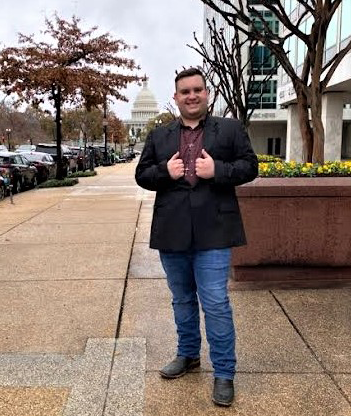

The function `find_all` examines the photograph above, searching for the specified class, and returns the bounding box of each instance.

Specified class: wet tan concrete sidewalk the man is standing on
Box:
[0,162,351,416]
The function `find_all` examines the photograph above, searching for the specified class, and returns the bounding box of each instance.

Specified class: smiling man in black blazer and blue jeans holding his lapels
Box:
[135,68,258,406]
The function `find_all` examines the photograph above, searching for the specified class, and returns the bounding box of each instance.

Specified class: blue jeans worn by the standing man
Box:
[160,248,236,379]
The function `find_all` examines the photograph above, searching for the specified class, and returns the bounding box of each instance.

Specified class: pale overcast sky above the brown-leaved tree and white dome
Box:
[0,0,203,119]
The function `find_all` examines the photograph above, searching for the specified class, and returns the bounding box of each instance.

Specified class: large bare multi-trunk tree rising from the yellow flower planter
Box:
[201,0,351,163]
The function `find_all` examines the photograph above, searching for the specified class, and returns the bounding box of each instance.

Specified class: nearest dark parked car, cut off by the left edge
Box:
[0,152,38,193]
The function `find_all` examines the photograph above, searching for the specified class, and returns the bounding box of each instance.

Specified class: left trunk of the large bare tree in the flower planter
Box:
[295,88,313,162]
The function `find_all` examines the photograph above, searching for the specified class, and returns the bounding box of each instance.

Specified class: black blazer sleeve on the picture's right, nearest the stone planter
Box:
[214,122,258,186]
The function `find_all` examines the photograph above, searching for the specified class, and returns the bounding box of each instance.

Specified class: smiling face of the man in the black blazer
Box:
[174,75,208,120]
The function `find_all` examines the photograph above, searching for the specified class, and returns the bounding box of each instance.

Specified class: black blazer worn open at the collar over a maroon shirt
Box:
[135,116,258,251]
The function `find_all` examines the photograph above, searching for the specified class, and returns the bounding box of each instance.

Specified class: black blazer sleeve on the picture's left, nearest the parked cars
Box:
[135,132,172,191]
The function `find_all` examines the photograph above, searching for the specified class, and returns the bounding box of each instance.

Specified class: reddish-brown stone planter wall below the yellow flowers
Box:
[232,177,351,289]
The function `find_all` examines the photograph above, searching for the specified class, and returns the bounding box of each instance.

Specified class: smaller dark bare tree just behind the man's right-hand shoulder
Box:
[187,19,277,127]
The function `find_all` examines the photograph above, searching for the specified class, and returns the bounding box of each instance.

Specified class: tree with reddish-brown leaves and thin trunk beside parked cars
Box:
[0,14,141,179]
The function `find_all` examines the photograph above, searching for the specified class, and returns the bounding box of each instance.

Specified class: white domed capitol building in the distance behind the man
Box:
[124,77,160,138]
